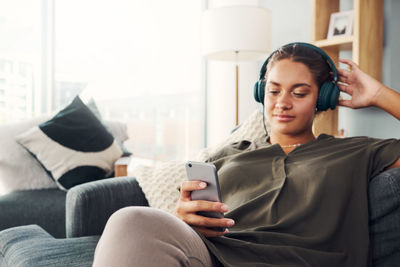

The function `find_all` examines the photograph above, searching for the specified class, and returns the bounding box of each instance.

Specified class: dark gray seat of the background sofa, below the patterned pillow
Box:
[0,189,66,238]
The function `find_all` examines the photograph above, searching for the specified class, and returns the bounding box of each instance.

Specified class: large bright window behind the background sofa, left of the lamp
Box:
[0,0,205,160]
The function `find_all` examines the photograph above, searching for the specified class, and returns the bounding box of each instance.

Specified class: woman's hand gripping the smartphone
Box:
[175,181,234,237]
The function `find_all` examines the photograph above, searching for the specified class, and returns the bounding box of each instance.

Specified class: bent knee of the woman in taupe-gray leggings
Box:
[93,207,213,267]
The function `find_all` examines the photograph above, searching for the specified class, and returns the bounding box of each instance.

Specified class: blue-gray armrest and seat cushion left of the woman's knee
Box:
[0,177,148,267]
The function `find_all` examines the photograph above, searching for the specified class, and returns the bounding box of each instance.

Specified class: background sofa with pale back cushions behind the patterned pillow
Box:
[0,97,129,238]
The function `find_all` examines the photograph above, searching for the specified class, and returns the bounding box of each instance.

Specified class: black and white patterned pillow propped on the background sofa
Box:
[16,97,123,190]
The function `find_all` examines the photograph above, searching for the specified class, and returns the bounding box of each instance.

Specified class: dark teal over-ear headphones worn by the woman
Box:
[254,42,340,111]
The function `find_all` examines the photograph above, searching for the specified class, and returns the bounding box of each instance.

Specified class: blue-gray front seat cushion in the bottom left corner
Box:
[0,225,99,267]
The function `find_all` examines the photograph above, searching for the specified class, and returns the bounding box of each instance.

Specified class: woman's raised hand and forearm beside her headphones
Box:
[338,59,400,120]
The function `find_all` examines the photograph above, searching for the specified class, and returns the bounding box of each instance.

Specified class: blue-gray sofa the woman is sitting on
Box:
[0,168,400,267]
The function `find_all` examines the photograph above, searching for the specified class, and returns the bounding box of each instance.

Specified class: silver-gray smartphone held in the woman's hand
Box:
[185,161,225,232]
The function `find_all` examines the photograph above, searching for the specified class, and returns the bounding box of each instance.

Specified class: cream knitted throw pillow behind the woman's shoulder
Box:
[132,110,268,213]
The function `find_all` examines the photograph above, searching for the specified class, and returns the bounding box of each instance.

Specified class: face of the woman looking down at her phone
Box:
[264,59,318,137]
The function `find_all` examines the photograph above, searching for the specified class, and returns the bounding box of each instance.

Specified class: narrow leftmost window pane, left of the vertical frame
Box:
[0,0,41,122]
